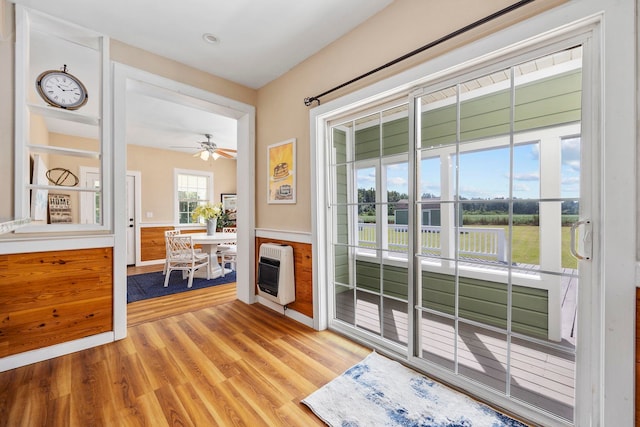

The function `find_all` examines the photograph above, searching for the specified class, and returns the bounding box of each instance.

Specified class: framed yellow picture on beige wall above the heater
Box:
[267,138,296,203]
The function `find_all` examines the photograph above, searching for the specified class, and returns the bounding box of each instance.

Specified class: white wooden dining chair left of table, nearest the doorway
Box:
[164,234,211,288]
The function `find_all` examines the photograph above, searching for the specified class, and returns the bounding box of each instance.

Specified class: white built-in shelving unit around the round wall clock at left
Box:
[14,5,112,233]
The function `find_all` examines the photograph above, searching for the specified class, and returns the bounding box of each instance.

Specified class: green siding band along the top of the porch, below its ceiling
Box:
[348,70,582,155]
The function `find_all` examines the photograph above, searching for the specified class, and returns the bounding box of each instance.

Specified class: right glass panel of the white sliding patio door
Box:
[414,48,581,421]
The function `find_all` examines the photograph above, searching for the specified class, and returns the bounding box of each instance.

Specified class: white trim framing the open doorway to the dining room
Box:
[112,62,256,339]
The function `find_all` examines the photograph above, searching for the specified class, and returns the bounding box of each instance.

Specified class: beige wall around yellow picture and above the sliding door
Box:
[256,0,563,232]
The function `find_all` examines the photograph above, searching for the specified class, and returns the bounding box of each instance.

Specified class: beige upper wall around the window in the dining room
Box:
[127,145,236,224]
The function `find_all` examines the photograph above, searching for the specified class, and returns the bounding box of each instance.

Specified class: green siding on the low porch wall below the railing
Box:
[356,261,549,339]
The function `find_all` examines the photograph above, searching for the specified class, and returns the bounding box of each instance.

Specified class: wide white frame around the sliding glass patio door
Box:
[310,4,640,425]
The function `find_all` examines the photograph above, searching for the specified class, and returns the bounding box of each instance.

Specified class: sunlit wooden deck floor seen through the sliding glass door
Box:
[336,271,578,420]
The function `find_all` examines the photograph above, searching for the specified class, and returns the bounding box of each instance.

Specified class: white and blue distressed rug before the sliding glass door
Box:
[302,352,525,427]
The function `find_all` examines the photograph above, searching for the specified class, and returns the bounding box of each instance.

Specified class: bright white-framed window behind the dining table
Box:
[176,170,213,224]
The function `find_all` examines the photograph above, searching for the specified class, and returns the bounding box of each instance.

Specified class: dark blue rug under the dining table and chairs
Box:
[127,271,236,303]
